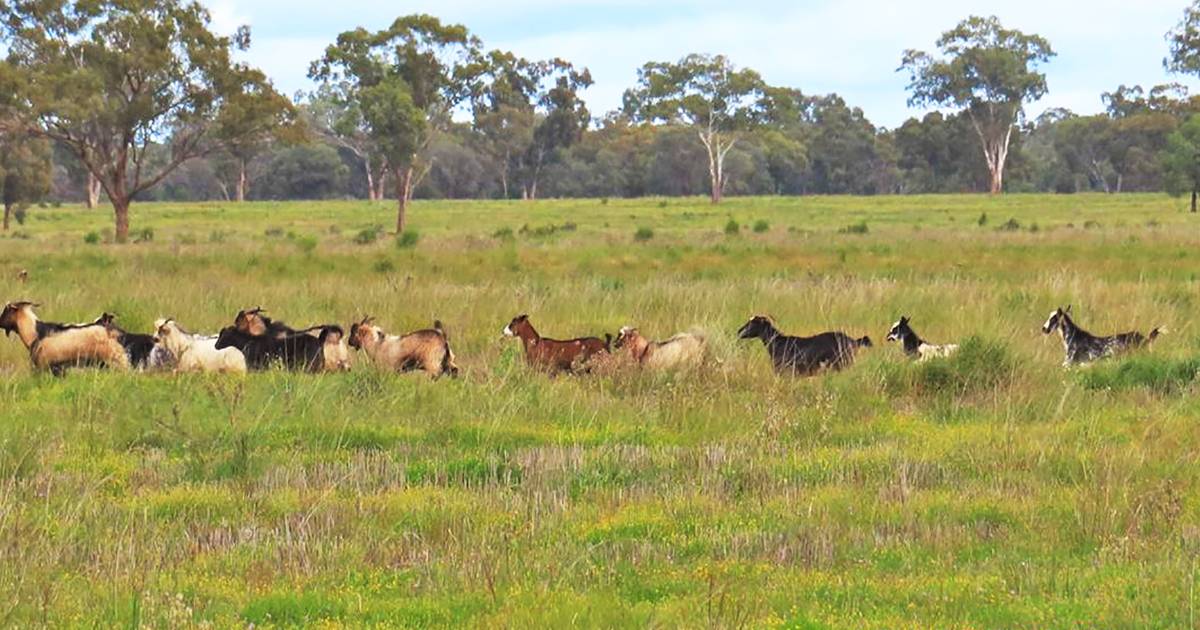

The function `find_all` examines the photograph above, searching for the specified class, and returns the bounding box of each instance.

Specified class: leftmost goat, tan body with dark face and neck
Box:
[0,301,130,376]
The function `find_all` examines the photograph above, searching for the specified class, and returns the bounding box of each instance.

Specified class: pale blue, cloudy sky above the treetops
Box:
[202,0,1200,127]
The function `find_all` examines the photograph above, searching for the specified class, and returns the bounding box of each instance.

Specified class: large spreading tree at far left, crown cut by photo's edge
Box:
[0,0,294,242]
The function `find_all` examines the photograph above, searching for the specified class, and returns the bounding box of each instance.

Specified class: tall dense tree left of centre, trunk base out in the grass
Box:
[308,16,480,233]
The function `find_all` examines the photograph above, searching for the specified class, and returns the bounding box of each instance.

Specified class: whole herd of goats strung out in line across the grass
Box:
[0,301,1165,378]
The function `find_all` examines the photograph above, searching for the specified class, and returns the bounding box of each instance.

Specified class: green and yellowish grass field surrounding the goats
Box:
[0,196,1200,629]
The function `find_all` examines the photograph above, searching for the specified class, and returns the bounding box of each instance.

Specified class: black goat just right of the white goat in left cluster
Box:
[215,325,350,372]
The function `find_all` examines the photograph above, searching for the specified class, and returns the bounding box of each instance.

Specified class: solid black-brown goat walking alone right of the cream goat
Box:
[738,316,872,376]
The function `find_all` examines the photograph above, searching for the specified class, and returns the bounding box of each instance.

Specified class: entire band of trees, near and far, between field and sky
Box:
[0,0,1200,241]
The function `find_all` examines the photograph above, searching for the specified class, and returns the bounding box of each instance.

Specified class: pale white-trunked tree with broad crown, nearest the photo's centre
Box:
[624,54,767,204]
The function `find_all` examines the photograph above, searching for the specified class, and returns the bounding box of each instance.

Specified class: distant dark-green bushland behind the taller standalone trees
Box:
[42,85,1200,202]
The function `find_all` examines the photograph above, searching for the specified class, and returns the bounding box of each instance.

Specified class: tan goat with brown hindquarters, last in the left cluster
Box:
[350,317,458,378]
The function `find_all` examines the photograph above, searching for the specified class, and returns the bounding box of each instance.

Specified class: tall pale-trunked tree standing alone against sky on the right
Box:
[900,16,1055,194]
